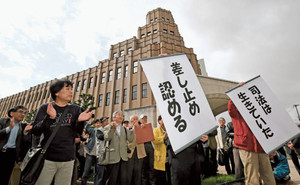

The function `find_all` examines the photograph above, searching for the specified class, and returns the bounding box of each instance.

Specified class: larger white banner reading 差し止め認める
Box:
[140,54,217,154]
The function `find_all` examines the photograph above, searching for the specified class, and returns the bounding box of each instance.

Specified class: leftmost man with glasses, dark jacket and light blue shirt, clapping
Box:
[0,105,32,185]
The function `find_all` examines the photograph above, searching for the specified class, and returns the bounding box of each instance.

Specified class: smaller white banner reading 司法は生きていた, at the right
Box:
[226,76,299,154]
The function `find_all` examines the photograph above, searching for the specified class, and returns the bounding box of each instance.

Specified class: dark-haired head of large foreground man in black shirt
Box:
[50,79,73,102]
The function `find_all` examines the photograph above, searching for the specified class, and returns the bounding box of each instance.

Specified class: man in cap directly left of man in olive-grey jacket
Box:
[81,117,108,185]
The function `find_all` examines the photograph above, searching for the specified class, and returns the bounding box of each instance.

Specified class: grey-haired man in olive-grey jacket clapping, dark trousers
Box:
[104,111,133,185]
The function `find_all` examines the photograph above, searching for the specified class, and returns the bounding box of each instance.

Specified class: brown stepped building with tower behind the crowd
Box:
[0,8,201,122]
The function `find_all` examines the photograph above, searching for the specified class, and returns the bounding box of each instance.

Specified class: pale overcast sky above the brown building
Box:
[0,0,300,120]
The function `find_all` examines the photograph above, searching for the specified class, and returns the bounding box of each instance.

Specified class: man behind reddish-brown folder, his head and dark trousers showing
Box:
[139,114,156,185]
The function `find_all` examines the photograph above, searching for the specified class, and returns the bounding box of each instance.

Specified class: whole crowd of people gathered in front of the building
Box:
[0,80,300,185]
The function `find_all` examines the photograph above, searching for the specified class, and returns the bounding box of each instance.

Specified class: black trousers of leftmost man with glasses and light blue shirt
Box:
[0,148,16,185]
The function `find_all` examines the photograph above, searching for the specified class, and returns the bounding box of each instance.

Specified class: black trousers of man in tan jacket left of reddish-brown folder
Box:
[127,148,143,185]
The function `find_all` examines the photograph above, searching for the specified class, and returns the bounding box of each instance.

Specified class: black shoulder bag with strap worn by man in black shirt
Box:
[20,106,69,185]
